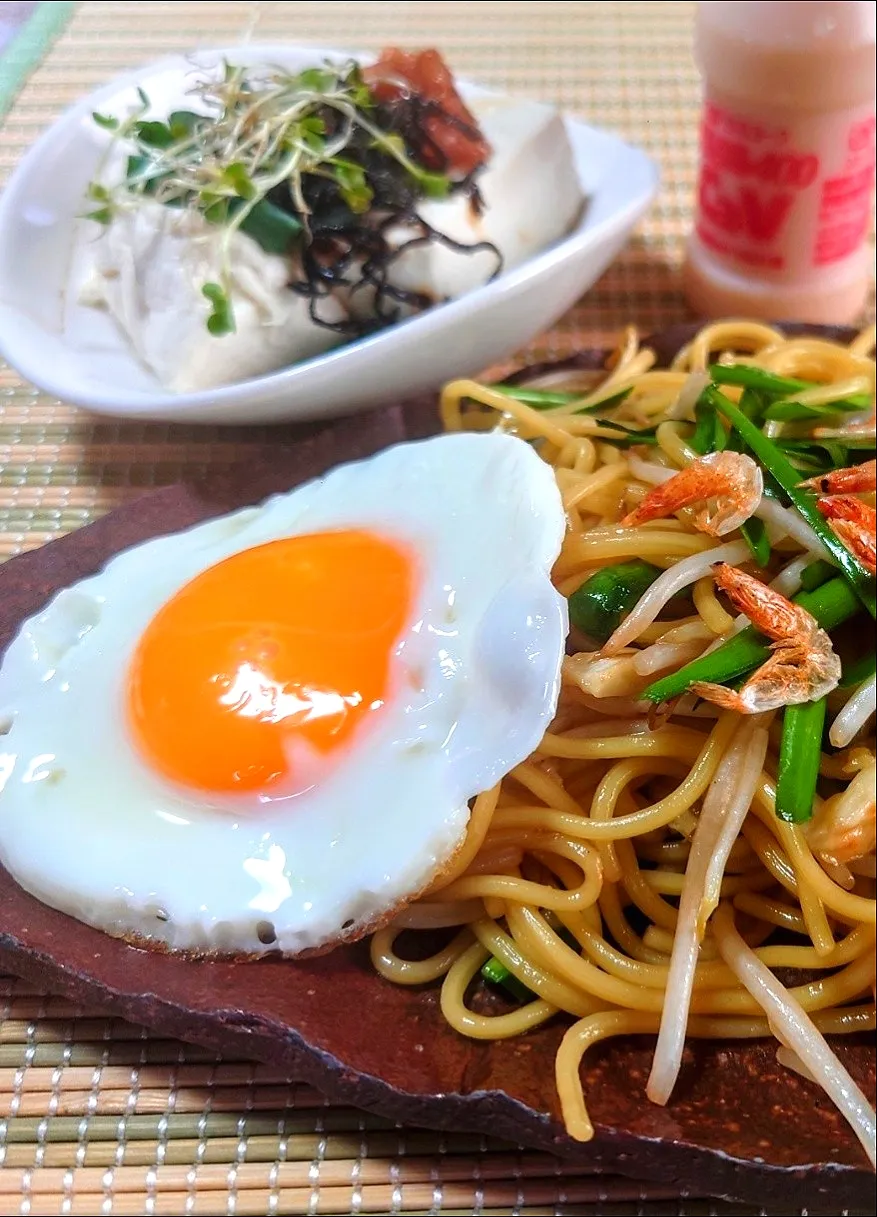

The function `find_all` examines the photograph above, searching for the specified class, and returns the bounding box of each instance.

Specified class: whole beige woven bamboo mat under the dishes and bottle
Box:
[0,0,870,1215]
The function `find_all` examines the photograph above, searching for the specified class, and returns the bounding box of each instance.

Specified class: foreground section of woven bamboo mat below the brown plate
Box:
[0,1002,870,1217]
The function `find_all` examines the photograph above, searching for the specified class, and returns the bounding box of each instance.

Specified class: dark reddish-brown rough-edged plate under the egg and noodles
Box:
[0,329,875,1212]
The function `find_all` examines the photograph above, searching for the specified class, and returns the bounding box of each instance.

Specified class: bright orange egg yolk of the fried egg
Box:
[128,529,416,793]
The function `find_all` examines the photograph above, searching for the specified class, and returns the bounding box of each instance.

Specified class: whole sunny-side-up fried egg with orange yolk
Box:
[0,433,567,955]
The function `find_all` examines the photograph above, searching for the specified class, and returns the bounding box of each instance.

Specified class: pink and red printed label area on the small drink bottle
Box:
[696,101,876,281]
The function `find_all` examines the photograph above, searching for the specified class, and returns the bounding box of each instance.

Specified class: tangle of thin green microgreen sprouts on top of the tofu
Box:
[88,55,491,335]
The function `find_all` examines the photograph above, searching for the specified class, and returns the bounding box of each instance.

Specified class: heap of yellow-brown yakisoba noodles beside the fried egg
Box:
[364,321,877,1160]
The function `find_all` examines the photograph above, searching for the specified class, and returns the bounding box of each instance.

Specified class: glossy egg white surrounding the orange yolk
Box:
[0,433,567,955]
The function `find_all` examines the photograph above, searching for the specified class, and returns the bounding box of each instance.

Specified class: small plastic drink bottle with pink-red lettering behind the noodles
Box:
[684,0,876,324]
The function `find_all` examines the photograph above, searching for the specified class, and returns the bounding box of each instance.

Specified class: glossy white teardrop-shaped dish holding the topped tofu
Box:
[0,44,658,424]
